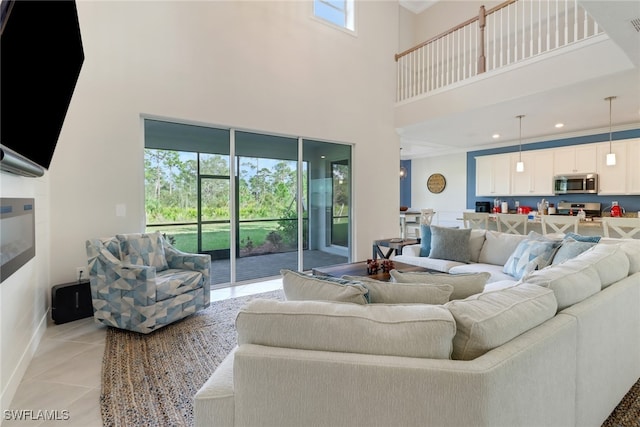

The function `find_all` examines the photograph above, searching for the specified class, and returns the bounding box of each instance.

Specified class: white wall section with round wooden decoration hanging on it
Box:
[411,153,467,226]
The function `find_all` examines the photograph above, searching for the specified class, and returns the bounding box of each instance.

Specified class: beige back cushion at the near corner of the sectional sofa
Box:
[445,284,557,360]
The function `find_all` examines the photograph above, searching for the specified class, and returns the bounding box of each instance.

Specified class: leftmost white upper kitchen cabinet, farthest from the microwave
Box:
[476,154,515,196]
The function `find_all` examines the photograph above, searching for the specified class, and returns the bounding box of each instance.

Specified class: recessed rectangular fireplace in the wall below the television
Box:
[0,197,36,282]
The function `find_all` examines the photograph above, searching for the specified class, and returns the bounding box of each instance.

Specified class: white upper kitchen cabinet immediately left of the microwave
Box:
[511,150,553,196]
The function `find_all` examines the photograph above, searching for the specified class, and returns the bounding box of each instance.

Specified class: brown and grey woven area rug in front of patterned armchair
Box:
[100,290,284,427]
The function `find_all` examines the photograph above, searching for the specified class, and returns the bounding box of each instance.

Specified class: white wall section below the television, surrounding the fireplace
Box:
[0,172,51,412]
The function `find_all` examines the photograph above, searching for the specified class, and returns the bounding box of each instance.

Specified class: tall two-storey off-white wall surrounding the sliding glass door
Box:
[50,1,399,282]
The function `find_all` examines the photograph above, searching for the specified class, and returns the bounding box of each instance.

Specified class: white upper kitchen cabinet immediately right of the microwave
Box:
[596,141,638,195]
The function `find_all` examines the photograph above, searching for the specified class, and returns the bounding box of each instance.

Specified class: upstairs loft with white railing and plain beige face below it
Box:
[395,0,640,159]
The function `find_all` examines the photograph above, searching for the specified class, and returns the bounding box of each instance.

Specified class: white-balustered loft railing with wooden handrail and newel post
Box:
[396,0,603,102]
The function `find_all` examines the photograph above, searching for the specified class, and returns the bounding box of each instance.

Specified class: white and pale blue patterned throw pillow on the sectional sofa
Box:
[502,232,559,279]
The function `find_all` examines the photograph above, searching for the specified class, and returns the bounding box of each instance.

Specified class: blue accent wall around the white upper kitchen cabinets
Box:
[467,129,640,212]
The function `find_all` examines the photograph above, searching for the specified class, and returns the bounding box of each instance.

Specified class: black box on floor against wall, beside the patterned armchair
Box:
[51,280,93,325]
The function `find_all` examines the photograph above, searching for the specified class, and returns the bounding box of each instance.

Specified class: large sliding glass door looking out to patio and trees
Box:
[145,120,351,286]
